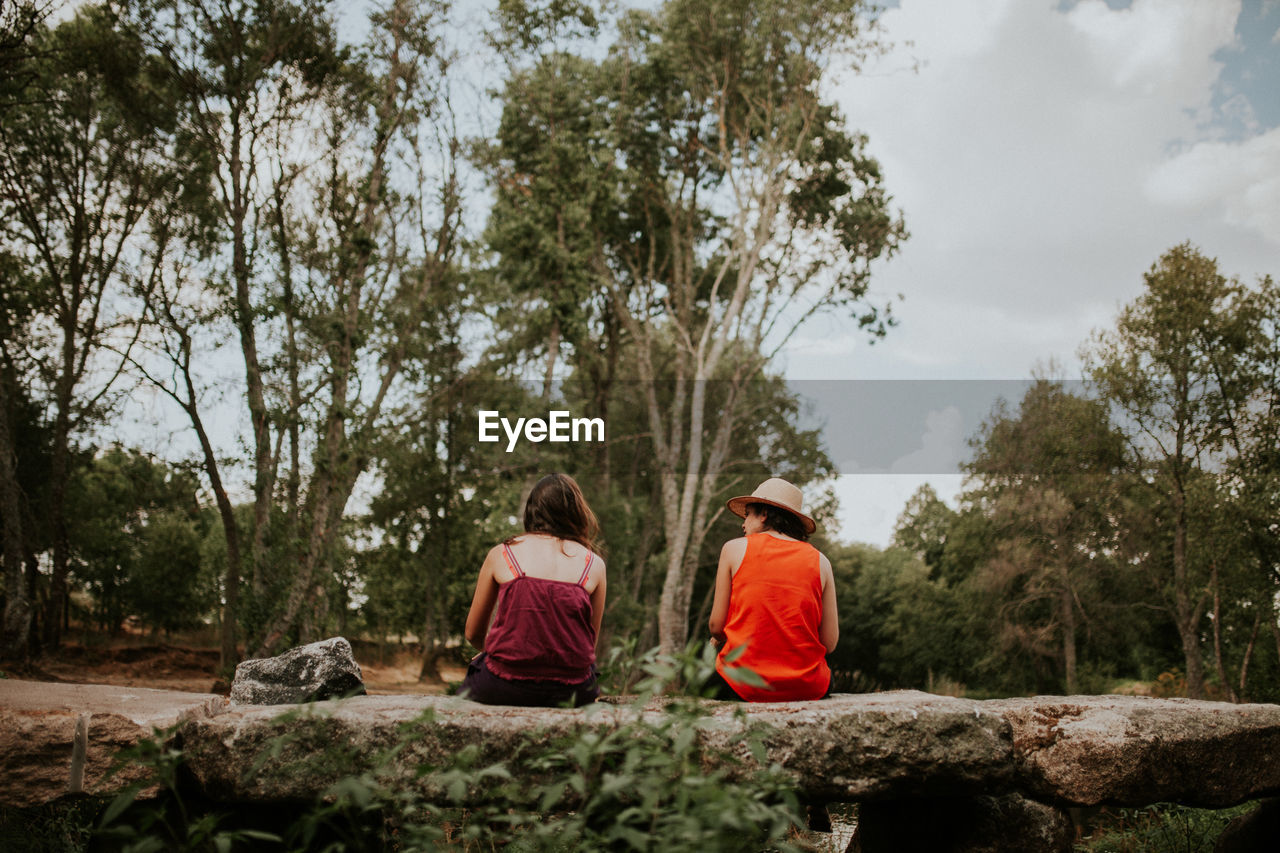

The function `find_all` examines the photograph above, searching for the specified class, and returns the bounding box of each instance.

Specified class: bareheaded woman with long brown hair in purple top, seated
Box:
[458,474,605,707]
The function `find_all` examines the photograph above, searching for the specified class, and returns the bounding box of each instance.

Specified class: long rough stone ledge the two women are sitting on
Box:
[0,680,1280,850]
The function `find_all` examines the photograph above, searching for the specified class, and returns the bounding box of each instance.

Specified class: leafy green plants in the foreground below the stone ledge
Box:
[87,648,803,853]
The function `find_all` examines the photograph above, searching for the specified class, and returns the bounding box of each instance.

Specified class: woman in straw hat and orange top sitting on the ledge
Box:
[709,478,840,702]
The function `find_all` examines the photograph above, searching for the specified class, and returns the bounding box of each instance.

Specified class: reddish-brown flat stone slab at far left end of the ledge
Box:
[0,679,228,807]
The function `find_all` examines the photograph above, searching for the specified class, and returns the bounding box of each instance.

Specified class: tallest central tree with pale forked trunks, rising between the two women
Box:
[476,0,905,651]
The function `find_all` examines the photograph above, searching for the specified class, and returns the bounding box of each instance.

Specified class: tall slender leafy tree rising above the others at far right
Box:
[1084,243,1248,698]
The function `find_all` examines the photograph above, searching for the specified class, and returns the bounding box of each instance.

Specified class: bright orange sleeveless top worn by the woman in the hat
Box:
[716,533,831,702]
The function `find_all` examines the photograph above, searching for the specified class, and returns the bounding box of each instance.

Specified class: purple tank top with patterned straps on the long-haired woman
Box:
[484,546,595,684]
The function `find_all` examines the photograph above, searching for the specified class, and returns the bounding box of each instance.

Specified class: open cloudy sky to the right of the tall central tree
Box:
[780,0,1280,546]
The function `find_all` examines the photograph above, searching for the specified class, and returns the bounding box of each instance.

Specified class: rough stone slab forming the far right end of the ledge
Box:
[982,695,1280,808]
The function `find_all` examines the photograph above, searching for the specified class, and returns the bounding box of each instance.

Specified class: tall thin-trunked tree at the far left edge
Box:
[0,6,173,644]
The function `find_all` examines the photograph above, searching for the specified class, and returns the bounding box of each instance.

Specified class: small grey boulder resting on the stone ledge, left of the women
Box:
[232,637,365,704]
